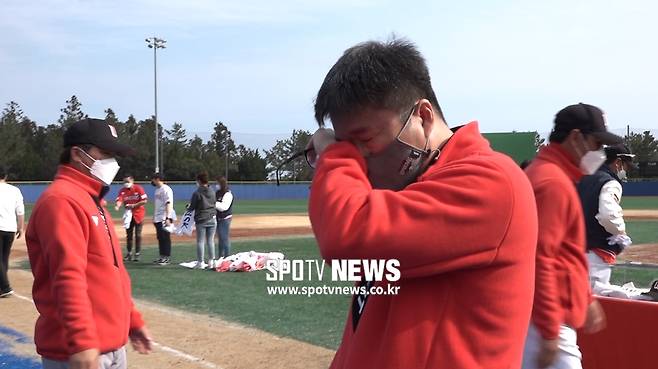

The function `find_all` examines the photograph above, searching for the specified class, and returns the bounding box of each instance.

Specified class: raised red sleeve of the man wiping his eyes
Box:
[309,142,513,278]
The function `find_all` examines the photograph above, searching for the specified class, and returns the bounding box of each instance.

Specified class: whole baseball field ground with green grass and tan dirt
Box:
[0,197,658,369]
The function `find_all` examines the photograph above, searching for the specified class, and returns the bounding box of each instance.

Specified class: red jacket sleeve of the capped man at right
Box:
[533,181,568,339]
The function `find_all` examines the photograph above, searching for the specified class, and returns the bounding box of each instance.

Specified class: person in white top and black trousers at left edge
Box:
[0,167,25,297]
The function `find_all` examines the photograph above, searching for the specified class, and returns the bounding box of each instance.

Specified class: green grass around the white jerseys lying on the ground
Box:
[127,238,350,349]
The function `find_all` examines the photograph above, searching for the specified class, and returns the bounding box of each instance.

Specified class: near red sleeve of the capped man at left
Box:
[39,198,99,353]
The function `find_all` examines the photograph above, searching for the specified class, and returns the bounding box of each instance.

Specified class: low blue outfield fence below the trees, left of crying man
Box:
[13,182,311,203]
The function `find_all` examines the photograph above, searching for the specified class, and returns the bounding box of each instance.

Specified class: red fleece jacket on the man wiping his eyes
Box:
[309,122,537,369]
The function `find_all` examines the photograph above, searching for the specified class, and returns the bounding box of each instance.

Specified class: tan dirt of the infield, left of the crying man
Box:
[0,214,334,369]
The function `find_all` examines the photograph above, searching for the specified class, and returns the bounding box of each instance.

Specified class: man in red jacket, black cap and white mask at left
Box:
[26,119,151,369]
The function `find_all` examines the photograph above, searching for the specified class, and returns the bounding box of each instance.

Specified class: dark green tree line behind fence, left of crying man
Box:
[0,95,312,181]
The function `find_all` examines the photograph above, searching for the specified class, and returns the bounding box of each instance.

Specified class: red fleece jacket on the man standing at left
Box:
[26,166,144,361]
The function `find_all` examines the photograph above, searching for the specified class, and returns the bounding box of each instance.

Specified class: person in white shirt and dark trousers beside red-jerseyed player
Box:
[151,173,176,265]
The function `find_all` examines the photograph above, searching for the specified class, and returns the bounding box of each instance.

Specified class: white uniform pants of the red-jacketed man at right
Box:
[522,323,582,369]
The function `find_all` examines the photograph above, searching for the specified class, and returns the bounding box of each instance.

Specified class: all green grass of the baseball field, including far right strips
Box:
[18,197,658,349]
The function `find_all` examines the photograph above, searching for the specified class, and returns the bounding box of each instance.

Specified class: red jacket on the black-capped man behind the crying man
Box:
[526,143,591,339]
